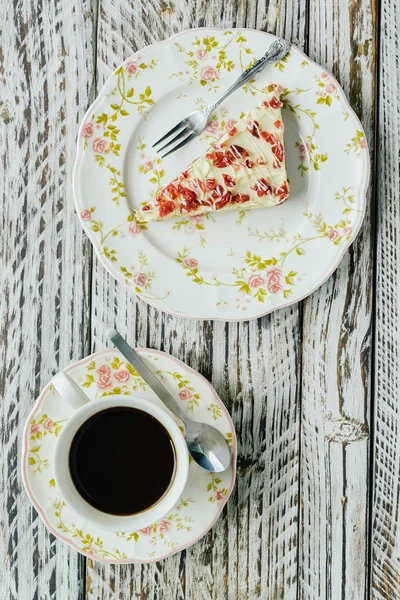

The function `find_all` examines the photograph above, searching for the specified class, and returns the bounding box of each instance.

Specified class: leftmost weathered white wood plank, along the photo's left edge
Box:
[0,0,93,600]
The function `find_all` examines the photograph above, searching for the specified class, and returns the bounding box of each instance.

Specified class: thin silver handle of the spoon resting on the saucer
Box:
[107,329,187,424]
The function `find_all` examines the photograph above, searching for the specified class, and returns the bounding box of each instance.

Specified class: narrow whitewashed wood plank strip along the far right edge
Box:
[372,0,400,600]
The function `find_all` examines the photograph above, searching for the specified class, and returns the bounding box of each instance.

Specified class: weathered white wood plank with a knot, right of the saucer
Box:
[299,0,375,600]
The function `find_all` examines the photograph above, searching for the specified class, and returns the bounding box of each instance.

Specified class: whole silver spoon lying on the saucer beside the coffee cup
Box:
[107,329,231,473]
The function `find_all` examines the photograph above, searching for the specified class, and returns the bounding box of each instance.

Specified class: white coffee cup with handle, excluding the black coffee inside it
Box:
[52,372,189,532]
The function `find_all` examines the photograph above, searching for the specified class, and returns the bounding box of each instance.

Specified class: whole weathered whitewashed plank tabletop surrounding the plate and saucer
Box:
[0,0,400,600]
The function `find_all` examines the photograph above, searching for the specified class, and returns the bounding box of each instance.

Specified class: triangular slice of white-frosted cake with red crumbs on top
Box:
[135,92,289,221]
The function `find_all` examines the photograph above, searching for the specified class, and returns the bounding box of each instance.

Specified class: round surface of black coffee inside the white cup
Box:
[69,406,176,515]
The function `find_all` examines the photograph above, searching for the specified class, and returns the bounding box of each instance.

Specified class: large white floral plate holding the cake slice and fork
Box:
[74,28,369,320]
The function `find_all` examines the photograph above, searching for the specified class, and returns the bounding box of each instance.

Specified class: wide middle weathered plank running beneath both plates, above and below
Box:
[86,0,306,600]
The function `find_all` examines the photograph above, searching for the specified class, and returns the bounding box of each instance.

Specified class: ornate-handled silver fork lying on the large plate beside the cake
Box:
[153,38,290,158]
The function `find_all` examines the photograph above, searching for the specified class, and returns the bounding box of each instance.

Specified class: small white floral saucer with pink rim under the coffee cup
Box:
[22,349,236,563]
